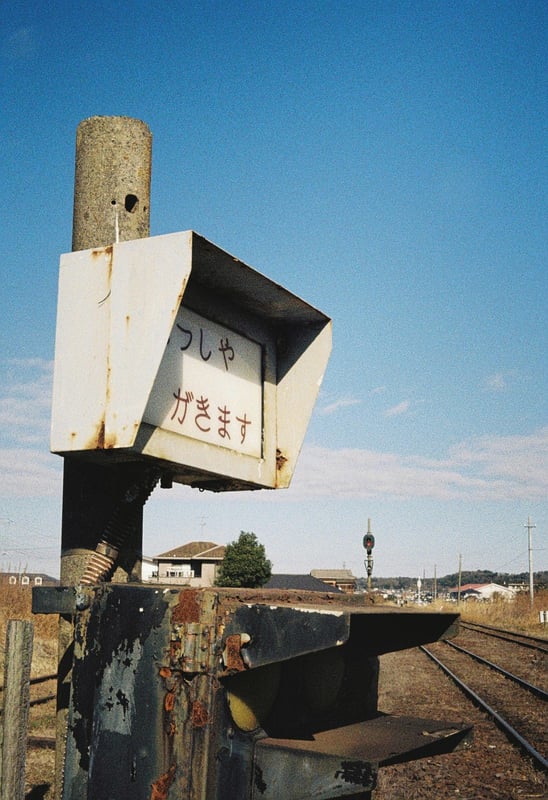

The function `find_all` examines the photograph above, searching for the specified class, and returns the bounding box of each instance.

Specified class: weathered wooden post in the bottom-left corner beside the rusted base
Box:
[0,619,33,800]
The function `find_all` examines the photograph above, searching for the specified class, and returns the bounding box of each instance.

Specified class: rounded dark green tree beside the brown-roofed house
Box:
[216,531,272,589]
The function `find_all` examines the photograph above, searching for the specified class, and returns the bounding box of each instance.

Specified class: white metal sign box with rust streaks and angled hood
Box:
[51,231,331,490]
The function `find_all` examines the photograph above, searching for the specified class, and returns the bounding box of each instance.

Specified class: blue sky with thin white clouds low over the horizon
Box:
[0,0,548,576]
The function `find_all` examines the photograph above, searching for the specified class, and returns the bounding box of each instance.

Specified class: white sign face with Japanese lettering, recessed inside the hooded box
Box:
[143,306,263,458]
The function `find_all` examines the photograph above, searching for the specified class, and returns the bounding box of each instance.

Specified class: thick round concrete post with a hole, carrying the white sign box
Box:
[56,117,152,800]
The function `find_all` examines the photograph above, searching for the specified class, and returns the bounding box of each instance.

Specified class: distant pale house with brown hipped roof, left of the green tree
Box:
[147,542,226,587]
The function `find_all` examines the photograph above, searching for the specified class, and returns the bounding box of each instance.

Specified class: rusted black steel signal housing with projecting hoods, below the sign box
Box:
[33,584,468,800]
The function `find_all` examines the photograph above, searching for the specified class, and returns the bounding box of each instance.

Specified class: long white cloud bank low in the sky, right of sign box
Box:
[292,427,548,501]
